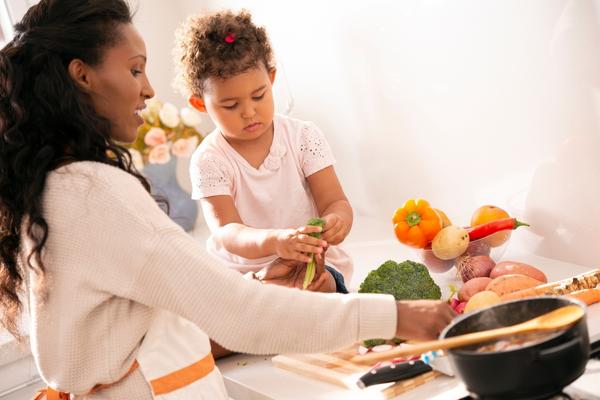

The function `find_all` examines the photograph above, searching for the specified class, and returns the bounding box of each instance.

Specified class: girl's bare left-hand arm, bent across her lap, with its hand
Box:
[201,195,327,262]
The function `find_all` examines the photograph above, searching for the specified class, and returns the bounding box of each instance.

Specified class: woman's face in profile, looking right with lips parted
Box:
[89,24,154,143]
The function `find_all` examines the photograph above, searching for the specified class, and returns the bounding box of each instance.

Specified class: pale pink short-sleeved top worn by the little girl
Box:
[190,115,352,282]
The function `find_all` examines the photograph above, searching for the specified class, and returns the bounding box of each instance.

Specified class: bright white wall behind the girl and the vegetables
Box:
[138,0,600,265]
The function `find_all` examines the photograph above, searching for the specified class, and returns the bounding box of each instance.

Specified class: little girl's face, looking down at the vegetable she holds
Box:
[203,63,275,143]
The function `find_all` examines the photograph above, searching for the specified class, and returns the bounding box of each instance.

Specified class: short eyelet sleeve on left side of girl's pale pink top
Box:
[190,154,232,199]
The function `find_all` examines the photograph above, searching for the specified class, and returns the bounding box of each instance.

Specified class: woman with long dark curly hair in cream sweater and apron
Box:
[0,0,453,399]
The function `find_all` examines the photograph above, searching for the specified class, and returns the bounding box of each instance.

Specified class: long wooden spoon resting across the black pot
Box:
[351,305,584,363]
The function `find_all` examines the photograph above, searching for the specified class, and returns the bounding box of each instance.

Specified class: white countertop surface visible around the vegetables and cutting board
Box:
[217,238,600,400]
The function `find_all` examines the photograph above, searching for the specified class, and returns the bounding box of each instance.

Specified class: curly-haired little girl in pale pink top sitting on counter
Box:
[176,11,352,292]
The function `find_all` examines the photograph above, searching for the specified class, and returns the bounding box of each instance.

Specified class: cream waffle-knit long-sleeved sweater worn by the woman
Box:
[24,162,396,399]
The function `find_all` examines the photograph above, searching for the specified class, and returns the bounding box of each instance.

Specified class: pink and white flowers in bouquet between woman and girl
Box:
[127,98,203,170]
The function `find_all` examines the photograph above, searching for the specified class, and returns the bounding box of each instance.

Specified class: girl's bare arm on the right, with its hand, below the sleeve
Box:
[306,166,353,245]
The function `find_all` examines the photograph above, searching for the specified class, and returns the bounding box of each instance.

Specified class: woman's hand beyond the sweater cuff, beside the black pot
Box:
[396,300,456,340]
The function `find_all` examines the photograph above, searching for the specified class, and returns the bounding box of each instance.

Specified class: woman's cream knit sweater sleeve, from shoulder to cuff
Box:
[74,166,396,354]
